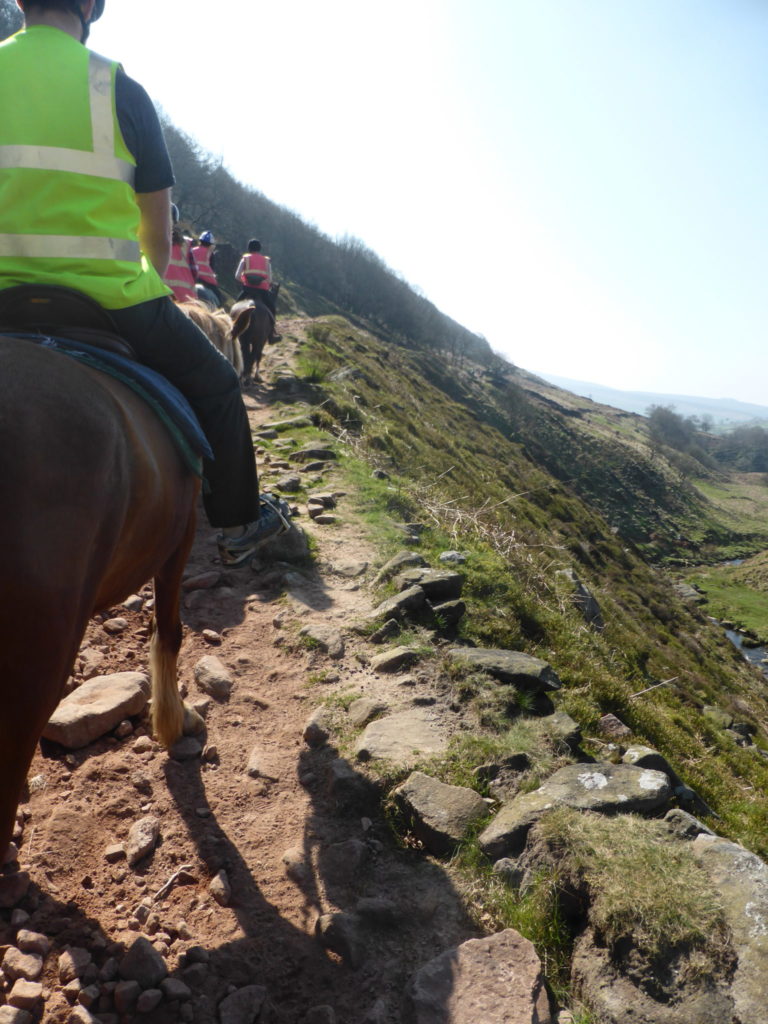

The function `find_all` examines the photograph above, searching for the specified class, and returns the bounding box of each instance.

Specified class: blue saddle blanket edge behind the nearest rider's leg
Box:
[37,335,213,477]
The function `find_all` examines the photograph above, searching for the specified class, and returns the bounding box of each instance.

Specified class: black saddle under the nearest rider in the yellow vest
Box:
[0,285,136,360]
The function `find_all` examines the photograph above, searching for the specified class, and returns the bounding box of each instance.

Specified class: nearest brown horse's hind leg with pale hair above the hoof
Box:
[150,510,195,746]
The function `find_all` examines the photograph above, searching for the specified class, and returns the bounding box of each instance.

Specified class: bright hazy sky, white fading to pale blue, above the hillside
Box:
[91,0,768,403]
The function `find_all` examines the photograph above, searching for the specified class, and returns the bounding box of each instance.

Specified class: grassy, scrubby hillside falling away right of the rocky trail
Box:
[278,316,768,855]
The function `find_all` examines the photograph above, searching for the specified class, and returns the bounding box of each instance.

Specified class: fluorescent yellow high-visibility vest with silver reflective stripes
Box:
[0,26,170,309]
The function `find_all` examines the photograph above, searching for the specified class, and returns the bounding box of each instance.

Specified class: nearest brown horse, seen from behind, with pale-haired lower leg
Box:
[0,335,199,862]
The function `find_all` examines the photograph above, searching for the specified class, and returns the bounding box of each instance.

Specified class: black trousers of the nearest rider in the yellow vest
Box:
[110,298,259,527]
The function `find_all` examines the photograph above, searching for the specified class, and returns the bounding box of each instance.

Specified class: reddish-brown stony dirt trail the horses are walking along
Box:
[0,321,481,1024]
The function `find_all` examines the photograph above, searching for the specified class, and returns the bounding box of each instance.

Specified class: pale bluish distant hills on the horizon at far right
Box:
[537,372,768,429]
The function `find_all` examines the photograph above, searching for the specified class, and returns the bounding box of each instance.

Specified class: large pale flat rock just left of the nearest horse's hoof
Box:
[43,672,151,751]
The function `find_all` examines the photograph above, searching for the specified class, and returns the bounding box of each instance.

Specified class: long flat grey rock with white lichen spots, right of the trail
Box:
[479,763,672,860]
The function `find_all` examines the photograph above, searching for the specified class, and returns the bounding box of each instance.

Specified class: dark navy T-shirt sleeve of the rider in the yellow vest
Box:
[115,69,174,193]
